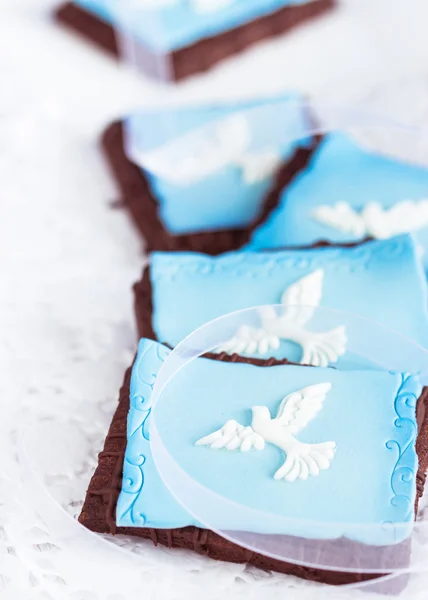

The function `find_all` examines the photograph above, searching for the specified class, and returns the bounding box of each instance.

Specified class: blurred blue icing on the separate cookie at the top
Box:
[76,0,311,52]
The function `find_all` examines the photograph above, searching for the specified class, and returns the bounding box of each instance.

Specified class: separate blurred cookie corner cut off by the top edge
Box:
[57,0,335,80]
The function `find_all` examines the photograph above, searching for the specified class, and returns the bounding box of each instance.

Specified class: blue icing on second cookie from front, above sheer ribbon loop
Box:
[150,235,428,365]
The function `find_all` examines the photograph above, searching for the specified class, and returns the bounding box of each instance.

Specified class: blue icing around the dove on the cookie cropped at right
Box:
[249,133,428,270]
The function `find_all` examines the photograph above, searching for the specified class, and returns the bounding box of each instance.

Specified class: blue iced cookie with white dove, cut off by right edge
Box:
[249,133,428,270]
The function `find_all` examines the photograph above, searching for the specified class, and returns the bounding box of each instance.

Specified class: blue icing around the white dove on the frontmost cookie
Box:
[117,340,422,545]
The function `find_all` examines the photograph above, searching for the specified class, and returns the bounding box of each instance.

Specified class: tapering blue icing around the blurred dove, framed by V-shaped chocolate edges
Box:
[127,93,309,235]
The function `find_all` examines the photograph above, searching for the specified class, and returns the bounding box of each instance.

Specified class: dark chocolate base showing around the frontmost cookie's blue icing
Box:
[79,355,428,592]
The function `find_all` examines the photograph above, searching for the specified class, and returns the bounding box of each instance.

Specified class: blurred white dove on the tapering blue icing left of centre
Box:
[129,115,282,186]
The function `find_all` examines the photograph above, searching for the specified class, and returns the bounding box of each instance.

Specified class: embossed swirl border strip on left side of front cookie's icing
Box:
[116,343,169,524]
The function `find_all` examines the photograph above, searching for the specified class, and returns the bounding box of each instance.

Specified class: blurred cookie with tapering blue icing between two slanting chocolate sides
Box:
[98,93,318,254]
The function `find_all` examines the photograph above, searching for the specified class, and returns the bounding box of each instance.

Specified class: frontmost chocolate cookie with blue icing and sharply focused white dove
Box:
[80,340,428,583]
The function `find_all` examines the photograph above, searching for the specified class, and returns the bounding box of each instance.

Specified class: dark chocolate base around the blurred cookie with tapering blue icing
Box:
[101,122,320,255]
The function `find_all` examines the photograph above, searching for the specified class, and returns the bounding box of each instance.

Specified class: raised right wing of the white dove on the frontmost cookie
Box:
[276,383,331,435]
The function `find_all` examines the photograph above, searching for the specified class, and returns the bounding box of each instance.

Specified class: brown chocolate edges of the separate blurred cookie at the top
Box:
[54,0,336,81]
